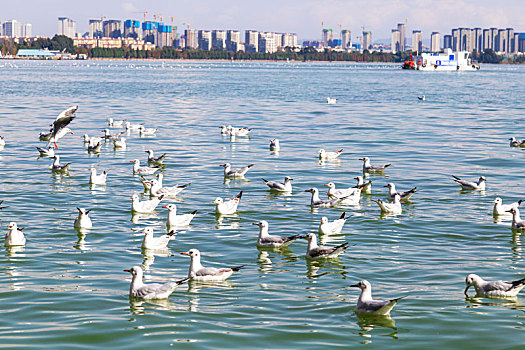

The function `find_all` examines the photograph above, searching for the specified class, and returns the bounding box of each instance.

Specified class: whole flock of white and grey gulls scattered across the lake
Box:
[0,106,525,315]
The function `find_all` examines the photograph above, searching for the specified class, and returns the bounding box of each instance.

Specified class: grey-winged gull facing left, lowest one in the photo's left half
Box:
[124,266,188,300]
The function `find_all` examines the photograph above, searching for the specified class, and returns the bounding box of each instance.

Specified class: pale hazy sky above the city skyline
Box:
[0,0,525,40]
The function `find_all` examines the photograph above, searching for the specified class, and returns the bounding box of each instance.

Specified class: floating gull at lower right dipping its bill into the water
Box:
[464,273,525,298]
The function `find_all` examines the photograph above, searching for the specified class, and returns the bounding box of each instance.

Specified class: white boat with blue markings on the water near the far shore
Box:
[402,49,479,71]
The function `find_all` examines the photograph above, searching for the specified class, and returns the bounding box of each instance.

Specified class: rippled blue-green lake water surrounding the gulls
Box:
[0,61,525,349]
